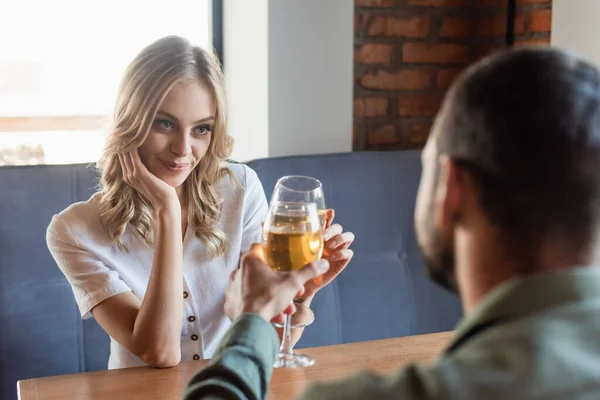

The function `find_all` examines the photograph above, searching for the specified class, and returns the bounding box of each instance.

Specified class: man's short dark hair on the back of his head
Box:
[437,48,600,258]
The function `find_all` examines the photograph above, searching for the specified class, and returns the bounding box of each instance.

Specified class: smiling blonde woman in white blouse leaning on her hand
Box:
[47,37,354,369]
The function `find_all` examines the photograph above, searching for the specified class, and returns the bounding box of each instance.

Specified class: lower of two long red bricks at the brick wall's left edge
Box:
[360,69,431,90]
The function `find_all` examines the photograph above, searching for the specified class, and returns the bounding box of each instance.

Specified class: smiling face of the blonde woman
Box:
[139,81,216,188]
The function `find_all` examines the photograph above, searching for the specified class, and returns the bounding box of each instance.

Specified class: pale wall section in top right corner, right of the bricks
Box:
[551,0,600,67]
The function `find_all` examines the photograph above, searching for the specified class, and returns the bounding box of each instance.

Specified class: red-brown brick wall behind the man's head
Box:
[353,0,551,151]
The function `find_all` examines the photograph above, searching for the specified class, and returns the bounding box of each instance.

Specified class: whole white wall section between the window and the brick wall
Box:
[224,0,354,161]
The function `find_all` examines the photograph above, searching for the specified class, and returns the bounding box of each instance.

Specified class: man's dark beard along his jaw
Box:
[421,227,459,294]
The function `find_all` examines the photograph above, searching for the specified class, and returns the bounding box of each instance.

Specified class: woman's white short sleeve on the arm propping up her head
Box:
[46,215,131,319]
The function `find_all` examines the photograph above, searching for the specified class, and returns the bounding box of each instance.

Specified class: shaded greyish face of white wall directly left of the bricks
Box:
[269,0,354,156]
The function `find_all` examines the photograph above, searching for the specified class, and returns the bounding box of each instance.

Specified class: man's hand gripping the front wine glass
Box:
[225,244,329,321]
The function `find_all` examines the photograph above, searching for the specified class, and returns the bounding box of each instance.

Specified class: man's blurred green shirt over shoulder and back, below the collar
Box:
[302,310,600,399]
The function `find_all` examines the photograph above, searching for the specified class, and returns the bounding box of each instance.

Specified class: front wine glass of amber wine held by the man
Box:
[262,200,323,368]
